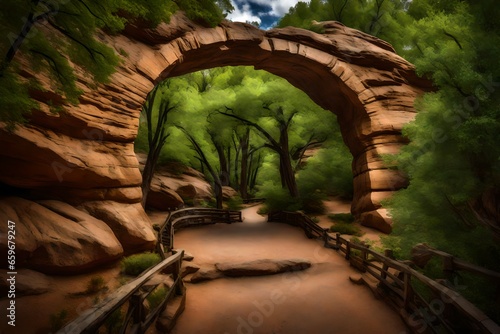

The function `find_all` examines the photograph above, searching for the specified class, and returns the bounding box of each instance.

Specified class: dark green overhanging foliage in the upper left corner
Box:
[0,0,233,125]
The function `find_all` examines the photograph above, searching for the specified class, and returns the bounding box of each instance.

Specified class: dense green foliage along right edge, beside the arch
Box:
[380,0,500,270]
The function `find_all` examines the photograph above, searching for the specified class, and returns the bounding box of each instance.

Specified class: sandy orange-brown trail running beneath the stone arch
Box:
[173,207,406,334]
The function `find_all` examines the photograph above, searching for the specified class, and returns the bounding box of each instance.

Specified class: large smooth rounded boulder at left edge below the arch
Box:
[0,197,123,274]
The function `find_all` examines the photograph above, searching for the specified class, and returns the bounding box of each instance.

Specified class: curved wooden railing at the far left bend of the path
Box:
[157,208,243,258]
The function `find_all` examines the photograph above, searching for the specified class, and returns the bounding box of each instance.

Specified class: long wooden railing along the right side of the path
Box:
[268,212,500,333]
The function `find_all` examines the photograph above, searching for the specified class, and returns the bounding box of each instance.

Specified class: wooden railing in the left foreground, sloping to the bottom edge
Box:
[57,250,185,334]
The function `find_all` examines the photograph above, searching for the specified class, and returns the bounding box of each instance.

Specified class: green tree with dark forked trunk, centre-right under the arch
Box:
[216,72,331,198]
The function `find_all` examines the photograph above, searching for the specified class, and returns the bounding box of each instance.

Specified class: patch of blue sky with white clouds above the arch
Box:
[227,0,309,29]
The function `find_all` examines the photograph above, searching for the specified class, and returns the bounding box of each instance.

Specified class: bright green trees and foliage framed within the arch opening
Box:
[135,67,352,212]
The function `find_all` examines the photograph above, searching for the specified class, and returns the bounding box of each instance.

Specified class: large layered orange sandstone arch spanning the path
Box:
[0,13,428,245]
